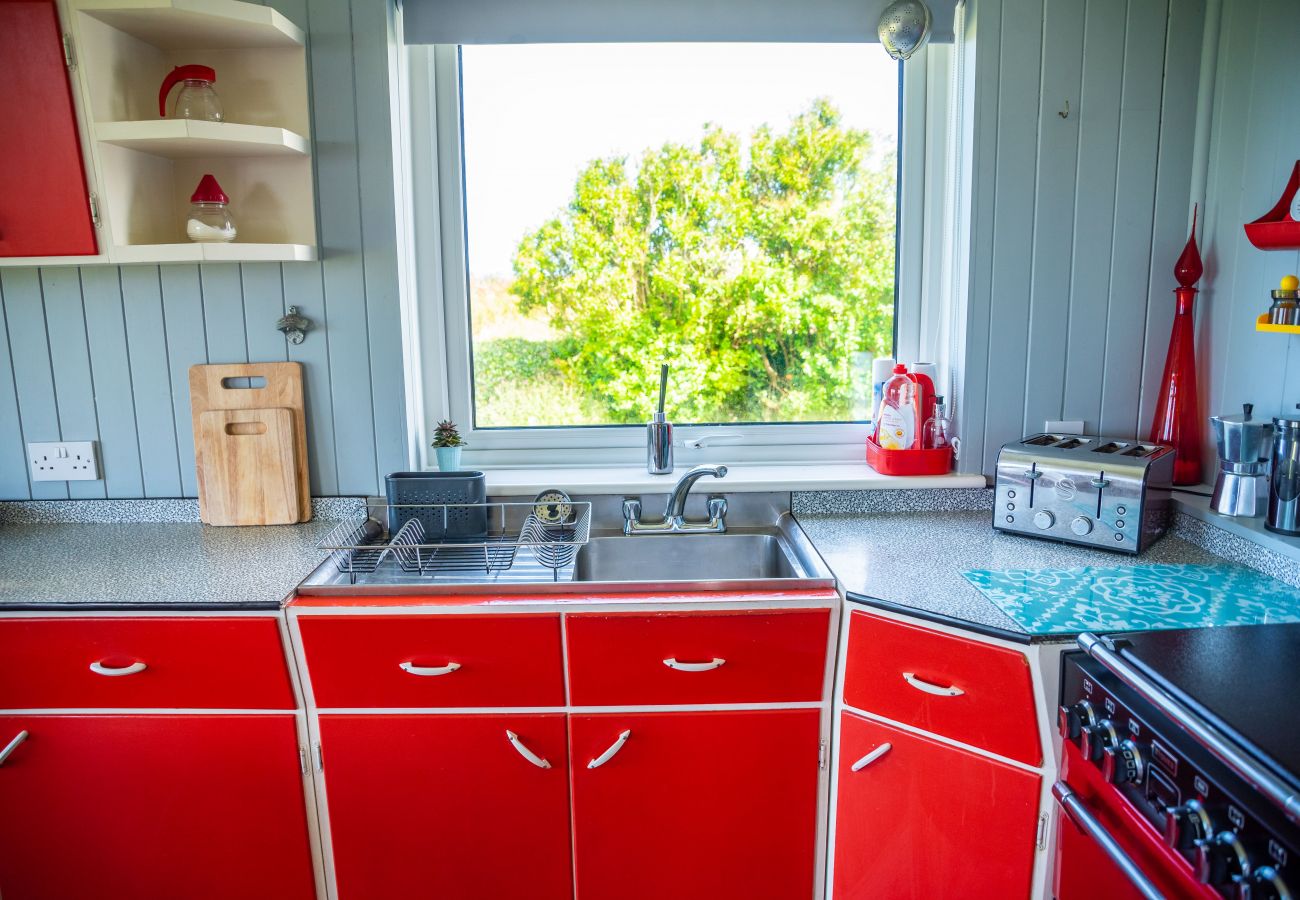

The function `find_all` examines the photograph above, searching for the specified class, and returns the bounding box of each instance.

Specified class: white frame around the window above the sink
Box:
[397,44,945,468]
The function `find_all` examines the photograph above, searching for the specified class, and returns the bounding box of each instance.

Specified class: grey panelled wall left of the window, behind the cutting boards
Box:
[0,0,406,499]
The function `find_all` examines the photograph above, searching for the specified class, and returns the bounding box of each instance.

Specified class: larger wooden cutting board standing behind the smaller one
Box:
[190,363,312,524]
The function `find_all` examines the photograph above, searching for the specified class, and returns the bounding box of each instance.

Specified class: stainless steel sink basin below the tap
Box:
[573,533,811,581]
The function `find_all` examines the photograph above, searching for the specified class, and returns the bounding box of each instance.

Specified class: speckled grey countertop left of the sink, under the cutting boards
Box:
[0,520,337,609]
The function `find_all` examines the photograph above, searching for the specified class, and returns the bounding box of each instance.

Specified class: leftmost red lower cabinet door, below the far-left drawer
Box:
[0,714,316,900]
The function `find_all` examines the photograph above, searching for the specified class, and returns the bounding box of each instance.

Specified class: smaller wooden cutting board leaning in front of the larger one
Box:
[195,408,299,525]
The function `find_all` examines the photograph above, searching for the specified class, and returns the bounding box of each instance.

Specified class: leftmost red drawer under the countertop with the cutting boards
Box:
[0,616,295,709]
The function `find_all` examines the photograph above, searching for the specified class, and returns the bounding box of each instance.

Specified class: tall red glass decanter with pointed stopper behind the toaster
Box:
[1151,207,1204,484]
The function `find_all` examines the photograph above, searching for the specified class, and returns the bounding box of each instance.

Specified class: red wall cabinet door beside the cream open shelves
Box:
[0,0,95,256]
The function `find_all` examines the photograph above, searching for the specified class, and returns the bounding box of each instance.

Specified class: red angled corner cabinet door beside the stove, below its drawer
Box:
[833,713,1040,900]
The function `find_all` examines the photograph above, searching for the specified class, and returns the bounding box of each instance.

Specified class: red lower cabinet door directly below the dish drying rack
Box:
[318,713,573,900]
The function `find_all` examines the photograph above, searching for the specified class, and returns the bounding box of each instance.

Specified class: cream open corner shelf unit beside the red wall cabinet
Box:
[66,0,316,263]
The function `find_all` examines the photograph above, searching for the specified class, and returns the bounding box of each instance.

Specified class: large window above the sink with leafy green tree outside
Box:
[411,43,923,464]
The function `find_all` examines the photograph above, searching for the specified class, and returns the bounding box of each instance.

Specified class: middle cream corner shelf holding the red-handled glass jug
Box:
[95,118,311,159]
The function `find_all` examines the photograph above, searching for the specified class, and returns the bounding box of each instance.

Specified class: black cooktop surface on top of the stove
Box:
[1114,623,1300,784]
